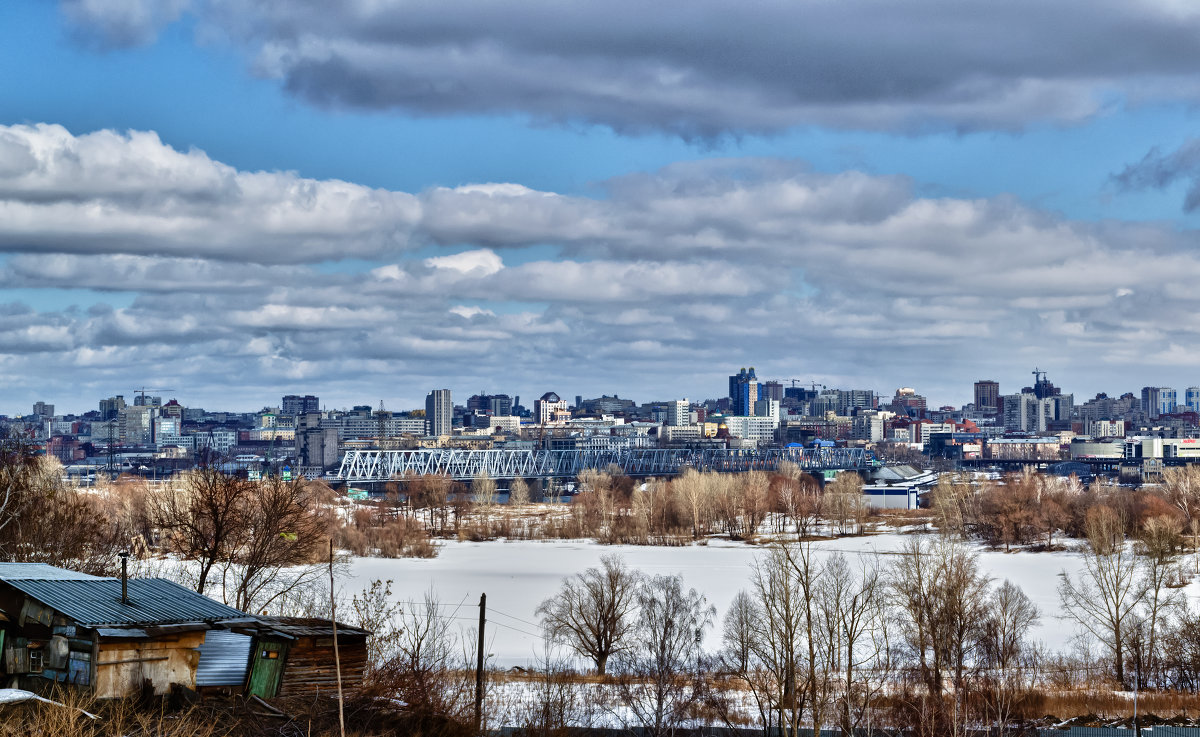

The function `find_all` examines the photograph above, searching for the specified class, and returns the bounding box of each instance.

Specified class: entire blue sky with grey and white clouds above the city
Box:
[0,0,1200,414]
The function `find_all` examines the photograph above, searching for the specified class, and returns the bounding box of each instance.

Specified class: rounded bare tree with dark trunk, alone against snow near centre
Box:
[538,556,641,675]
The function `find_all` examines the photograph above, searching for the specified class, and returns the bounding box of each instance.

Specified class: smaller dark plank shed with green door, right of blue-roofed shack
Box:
[233,617,371,699]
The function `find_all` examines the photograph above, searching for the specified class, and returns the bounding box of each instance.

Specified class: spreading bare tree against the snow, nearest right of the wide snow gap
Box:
[1058,505,1146,684]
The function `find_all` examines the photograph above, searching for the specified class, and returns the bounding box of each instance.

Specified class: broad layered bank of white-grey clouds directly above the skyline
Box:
[11,121,1200,410]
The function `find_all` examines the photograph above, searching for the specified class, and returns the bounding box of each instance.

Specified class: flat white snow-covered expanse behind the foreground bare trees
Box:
[340,532,1200,667]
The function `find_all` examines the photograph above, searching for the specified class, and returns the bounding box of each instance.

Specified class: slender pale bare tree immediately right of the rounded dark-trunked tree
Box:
[616,576,716,737]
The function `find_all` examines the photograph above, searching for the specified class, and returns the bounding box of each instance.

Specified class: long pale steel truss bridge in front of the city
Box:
[334,448,880,484]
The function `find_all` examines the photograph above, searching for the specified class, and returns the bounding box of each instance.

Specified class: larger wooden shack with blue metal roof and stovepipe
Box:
[0,563,254,697]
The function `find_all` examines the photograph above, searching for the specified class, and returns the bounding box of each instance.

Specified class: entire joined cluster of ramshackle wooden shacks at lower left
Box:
[0,563,371,699]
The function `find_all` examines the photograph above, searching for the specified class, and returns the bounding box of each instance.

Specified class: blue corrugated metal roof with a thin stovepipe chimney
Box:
[6,579,246,627]
